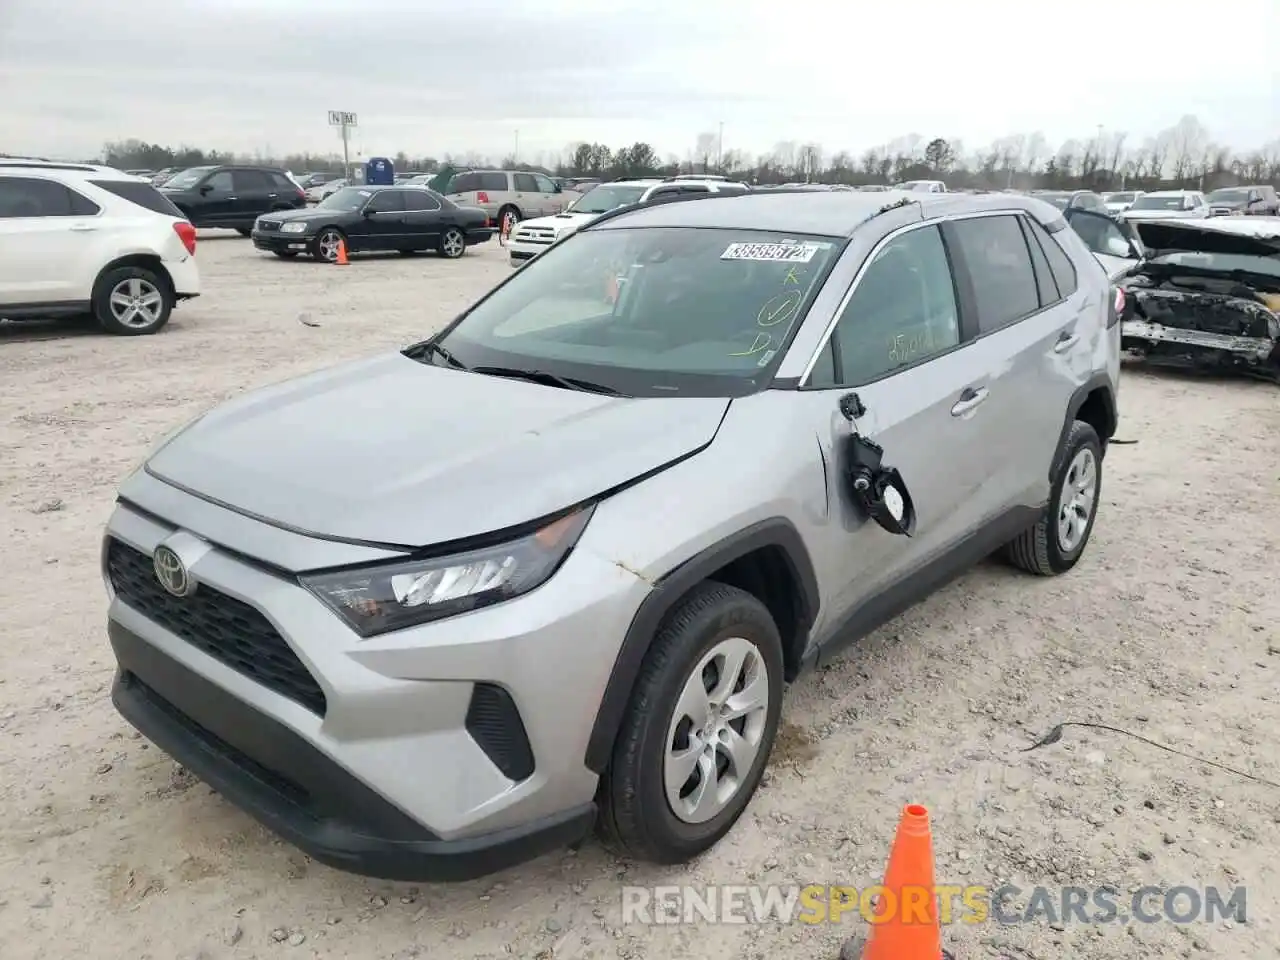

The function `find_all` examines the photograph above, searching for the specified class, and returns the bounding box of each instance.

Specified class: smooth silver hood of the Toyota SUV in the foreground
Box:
[146,353,730,547]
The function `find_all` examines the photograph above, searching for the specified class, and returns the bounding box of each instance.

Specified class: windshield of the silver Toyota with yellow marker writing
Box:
[439,227,844,397]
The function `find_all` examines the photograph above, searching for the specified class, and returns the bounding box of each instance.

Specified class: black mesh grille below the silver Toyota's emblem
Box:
[106,538,326,717]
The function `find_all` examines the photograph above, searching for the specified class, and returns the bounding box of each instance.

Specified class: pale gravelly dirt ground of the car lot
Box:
[0,236,1280,960]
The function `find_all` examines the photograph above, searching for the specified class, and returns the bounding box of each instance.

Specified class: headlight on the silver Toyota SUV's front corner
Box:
[301,507,594,637]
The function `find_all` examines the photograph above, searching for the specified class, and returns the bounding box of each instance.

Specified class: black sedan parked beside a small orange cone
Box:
[253,186,494,262]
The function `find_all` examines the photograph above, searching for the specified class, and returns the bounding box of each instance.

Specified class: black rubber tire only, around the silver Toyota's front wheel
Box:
[596,581,783,864]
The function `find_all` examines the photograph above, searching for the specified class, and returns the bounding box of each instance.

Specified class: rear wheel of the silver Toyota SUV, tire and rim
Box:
[1005,420,1102,576]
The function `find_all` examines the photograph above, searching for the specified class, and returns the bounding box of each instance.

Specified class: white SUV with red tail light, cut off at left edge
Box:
[0,159,200,337]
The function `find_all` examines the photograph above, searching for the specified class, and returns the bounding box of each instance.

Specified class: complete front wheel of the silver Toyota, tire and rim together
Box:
[598,581,783,864]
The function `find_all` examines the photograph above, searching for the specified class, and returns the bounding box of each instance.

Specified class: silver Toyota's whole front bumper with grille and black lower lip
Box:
[104,488,649,881]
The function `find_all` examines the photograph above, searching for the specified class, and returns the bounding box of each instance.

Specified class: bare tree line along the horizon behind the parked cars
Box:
[72,115,1280,191]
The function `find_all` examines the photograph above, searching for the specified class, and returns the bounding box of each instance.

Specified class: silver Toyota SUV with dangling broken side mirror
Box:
[102,185,1120,879]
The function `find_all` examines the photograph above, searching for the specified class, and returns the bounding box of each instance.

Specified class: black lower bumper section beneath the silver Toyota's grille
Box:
[109,622,595,882]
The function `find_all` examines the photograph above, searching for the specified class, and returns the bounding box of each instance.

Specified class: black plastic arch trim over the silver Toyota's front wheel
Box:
[585,517,819,774]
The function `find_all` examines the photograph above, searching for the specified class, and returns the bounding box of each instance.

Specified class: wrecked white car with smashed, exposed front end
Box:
[1066,210,1280,383]
